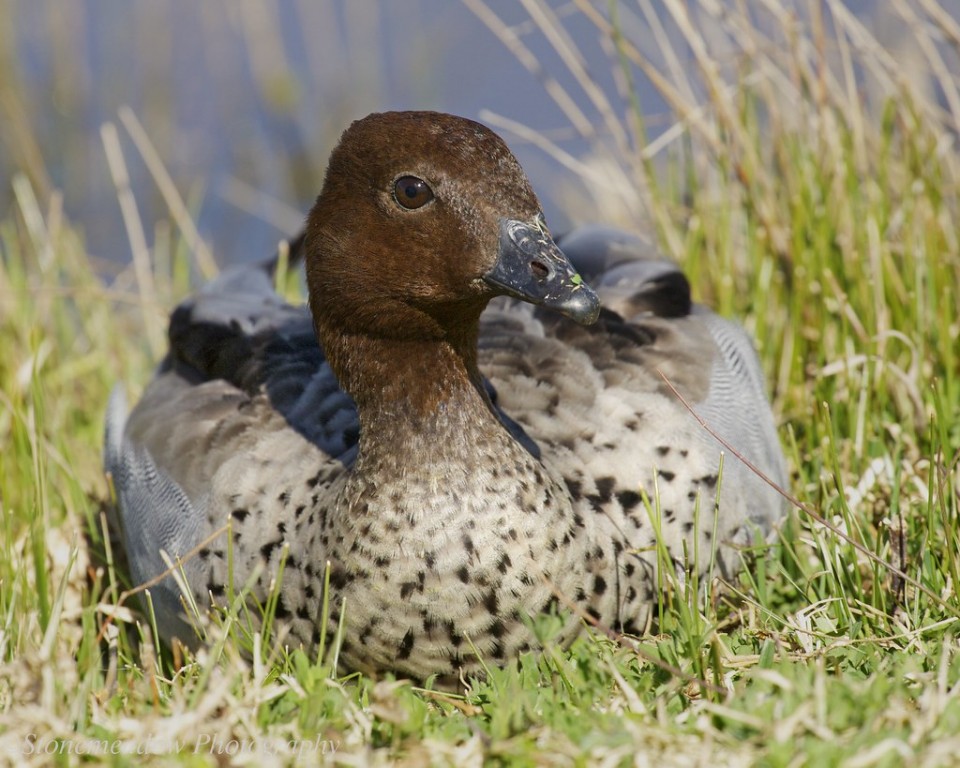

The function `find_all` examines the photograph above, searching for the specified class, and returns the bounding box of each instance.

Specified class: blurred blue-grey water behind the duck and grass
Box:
[0,0,944,263]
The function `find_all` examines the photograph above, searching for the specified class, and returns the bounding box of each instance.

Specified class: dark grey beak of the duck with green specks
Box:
[483,219,600,325]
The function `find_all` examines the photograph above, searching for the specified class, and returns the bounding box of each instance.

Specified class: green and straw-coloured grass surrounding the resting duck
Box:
[0,0,960,766]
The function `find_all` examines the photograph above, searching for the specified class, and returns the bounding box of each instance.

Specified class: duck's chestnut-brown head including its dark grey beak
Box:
[306,112,599,348]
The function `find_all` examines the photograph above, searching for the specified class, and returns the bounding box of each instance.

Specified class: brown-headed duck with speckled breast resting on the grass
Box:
[104,111,787,680]
